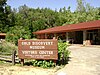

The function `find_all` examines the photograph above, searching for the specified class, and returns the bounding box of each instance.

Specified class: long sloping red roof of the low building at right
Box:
[33,20,100,34]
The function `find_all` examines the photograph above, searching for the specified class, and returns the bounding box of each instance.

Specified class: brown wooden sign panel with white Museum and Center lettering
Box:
[18,39,58,60]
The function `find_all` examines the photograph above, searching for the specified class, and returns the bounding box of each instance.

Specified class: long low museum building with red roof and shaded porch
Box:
[33,20,100,45]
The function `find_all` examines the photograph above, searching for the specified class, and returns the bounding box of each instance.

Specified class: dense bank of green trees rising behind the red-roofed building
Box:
[0,0,100,45]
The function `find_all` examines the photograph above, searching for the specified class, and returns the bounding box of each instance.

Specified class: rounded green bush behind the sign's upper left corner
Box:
[6,26,30,45]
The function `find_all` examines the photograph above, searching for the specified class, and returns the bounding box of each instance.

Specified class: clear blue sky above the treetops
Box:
[7,0,100,11]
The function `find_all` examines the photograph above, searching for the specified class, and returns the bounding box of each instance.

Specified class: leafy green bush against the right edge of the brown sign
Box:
[58,42,71,65]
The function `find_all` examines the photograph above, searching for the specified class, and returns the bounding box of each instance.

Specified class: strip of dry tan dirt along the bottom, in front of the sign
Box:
[0,66,55,75]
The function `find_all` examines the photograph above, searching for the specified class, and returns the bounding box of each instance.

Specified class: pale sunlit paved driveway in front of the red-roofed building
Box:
[57,45,100,75]
